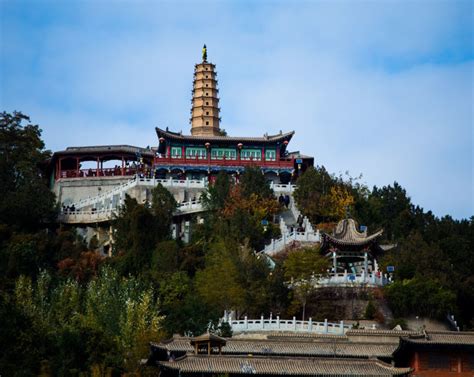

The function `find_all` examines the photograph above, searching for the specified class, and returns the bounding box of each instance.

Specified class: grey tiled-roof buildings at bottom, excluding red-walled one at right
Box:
[147,333,411,377]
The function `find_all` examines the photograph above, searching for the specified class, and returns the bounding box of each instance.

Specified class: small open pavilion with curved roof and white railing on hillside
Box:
[320,218,389,286]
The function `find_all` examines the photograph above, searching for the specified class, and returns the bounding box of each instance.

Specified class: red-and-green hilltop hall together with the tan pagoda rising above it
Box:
[154,46,314,183]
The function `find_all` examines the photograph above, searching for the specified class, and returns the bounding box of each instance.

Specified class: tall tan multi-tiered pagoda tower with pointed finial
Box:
[190,45,221,136]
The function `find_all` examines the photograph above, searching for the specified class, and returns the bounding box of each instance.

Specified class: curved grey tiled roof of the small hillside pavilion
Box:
[323,219,383,246]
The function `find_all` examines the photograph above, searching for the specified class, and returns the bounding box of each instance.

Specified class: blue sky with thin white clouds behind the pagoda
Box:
[0,0,474,219]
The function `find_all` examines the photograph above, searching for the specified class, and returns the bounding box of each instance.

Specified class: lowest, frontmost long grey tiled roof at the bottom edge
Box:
[159,355,411,376]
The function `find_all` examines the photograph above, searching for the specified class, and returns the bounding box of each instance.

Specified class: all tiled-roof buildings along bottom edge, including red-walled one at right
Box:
[147,330,474,377]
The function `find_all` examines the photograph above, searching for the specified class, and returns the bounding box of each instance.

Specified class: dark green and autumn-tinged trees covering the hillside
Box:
[0,113,474,376]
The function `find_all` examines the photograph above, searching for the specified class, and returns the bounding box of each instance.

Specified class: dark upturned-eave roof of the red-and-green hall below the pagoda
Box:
[155,127,295,145]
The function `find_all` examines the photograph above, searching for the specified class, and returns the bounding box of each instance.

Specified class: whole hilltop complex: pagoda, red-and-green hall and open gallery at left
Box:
[49,46,314,187]
